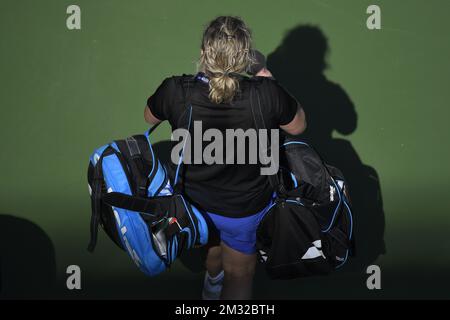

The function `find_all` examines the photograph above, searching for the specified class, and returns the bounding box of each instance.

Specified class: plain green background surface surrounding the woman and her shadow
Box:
[0,0,450,298]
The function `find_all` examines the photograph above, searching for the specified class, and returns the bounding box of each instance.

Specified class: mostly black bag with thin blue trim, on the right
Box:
[251,80,354,279]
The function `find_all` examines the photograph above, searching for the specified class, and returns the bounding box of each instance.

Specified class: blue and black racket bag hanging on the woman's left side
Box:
[88,127,208,276]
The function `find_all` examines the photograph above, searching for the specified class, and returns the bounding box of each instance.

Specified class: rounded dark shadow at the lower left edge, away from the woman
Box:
[0,214,56,299]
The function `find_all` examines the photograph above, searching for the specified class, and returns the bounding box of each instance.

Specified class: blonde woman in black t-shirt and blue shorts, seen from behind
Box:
[144,16,306,299]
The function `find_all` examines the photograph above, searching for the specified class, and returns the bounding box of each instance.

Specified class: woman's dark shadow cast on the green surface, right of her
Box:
[267,25,386,271]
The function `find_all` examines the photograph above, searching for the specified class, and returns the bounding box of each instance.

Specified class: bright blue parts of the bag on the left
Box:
[90,128,208,276]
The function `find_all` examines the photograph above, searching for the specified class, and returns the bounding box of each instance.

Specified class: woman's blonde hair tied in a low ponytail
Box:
[199,16,254,103]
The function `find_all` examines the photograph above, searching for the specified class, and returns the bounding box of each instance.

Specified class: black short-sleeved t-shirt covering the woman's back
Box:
[148,74,298,217]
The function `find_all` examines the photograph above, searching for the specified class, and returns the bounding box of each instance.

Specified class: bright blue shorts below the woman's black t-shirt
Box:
[206,202,272,254]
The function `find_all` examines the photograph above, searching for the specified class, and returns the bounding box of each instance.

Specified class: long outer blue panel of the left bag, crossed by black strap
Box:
[102,154,166,276]
